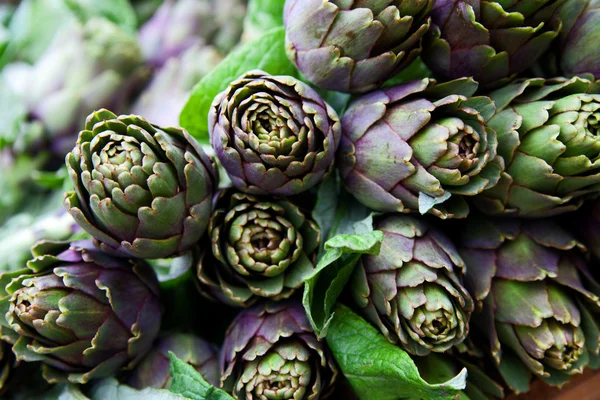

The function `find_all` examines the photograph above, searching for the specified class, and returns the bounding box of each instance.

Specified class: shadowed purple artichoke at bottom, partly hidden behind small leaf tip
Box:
[126,333,220,389]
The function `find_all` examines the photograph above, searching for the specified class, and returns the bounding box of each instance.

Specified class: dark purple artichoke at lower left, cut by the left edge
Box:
[0,241,161,383]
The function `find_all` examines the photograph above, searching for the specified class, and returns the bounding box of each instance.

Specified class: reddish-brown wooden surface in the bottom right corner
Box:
[507,370,600,400]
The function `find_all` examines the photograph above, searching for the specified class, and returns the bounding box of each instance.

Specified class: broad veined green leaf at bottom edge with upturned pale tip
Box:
[326,304,467,400]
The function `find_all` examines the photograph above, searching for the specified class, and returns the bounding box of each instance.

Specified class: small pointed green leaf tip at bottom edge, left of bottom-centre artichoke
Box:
[169,351,233,400]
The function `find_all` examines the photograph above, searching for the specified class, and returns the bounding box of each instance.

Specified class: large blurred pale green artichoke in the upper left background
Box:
[0,18,148,158]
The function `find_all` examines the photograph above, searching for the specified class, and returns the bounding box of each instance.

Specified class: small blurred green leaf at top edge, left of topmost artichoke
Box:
[243,0,285,40]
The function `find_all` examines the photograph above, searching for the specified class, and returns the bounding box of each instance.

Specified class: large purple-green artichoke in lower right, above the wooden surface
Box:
[459,217,600,390]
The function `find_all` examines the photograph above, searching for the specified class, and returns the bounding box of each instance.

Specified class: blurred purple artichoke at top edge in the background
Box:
[138,0,246,68]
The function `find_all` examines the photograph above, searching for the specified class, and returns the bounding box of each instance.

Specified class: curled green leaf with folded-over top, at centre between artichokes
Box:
[302,228,383,338]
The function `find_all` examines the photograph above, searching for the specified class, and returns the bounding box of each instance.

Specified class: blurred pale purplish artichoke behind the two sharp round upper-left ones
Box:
[132,45,222,126]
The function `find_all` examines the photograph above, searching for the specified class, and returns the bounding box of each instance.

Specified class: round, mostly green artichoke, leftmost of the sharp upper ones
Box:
[65,109,218,259]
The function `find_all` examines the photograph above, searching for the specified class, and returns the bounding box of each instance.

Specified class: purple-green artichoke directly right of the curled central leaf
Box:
[352,215,474,356]
